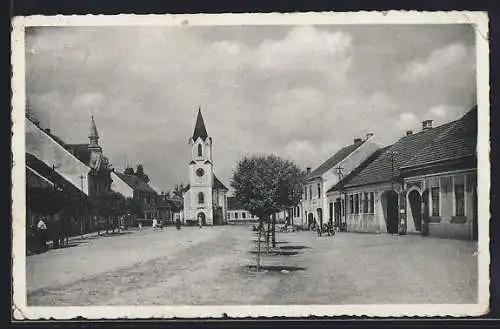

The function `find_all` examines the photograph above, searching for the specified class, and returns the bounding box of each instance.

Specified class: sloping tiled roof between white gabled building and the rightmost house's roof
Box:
[344,121,456,187]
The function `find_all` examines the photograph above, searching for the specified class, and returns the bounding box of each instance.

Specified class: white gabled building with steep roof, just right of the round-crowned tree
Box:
[298,134,381,227]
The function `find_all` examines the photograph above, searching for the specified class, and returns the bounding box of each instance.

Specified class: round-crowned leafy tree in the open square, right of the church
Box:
[231,155,304,268]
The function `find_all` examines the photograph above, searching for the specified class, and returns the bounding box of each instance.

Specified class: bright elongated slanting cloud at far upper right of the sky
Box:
[403,43,472,81]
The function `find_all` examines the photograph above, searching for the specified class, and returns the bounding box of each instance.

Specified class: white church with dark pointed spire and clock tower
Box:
[184,109,229,225]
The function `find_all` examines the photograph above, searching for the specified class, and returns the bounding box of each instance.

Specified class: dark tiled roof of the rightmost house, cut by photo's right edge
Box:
[401,107,477,169]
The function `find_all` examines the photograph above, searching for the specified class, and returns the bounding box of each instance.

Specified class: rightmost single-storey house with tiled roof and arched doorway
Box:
[400,108,477,239]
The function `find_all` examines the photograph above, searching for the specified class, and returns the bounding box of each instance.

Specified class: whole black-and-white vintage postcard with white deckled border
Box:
[12,11,490,320]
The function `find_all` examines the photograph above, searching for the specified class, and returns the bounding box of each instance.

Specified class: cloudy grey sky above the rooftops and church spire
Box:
[25,25,476,192]
